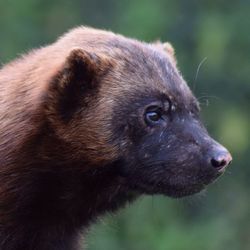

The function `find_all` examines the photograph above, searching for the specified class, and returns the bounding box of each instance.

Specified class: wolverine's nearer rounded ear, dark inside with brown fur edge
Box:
[47,48,113,122]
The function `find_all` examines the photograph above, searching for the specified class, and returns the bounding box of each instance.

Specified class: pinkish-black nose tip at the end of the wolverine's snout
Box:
[210,150,232,171]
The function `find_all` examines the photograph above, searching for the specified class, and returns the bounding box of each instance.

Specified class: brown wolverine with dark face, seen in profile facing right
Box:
[0,27,232,250]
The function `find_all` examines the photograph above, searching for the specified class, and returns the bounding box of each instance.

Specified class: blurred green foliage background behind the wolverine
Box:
[0,0,250,250]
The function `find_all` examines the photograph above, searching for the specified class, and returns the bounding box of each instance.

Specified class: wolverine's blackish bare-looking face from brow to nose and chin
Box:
[112,92,231,197]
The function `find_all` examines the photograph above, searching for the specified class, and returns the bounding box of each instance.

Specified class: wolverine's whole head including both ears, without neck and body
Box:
[50,27,232,197]
